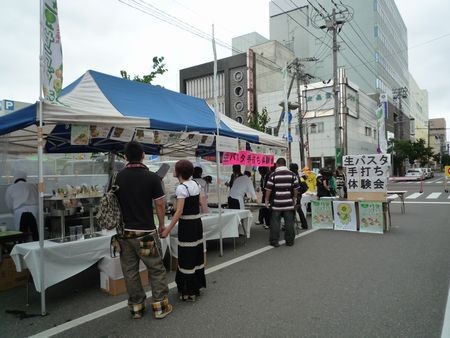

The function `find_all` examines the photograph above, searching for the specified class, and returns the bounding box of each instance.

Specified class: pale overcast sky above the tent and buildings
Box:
[0,0,450,135]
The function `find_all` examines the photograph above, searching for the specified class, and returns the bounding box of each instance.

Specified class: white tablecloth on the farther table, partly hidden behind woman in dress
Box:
[166,208,253,257]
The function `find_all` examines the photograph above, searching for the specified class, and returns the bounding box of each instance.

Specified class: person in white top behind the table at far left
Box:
[5,170,39,241]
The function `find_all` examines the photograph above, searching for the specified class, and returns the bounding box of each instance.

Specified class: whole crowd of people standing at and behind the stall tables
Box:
[5,141,347,319]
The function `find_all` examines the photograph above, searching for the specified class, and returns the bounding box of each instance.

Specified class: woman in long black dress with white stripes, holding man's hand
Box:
[161,160,206,301]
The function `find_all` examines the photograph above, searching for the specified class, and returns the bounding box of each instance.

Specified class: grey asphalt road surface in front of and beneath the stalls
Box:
[0,183,450,337]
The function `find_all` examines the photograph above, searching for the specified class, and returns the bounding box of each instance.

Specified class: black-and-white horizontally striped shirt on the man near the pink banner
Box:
[266,167,299,211]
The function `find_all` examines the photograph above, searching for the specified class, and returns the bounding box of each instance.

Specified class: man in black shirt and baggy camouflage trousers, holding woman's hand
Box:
[115,141,172,319]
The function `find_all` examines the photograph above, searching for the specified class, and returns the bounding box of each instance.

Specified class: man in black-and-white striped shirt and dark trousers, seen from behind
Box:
[265,158,299,247]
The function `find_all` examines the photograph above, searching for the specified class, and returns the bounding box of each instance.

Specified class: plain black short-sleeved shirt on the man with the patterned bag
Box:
[115,164,164,231]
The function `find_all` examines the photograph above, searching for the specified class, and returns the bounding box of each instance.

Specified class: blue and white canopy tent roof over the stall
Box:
[0,70,286,156]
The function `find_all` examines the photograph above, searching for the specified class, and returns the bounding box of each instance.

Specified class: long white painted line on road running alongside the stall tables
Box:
[30,229,319,338]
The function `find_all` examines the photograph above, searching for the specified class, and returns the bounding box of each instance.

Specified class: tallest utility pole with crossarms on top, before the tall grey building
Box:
[310,0,353,167]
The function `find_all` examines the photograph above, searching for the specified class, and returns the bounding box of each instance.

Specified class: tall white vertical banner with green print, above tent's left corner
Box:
[41,0,63,103]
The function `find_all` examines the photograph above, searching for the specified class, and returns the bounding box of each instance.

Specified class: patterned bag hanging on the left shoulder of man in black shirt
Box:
[95,173,123,233]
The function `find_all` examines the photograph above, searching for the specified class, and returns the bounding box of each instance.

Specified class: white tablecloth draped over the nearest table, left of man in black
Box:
[11,230,167,291]
